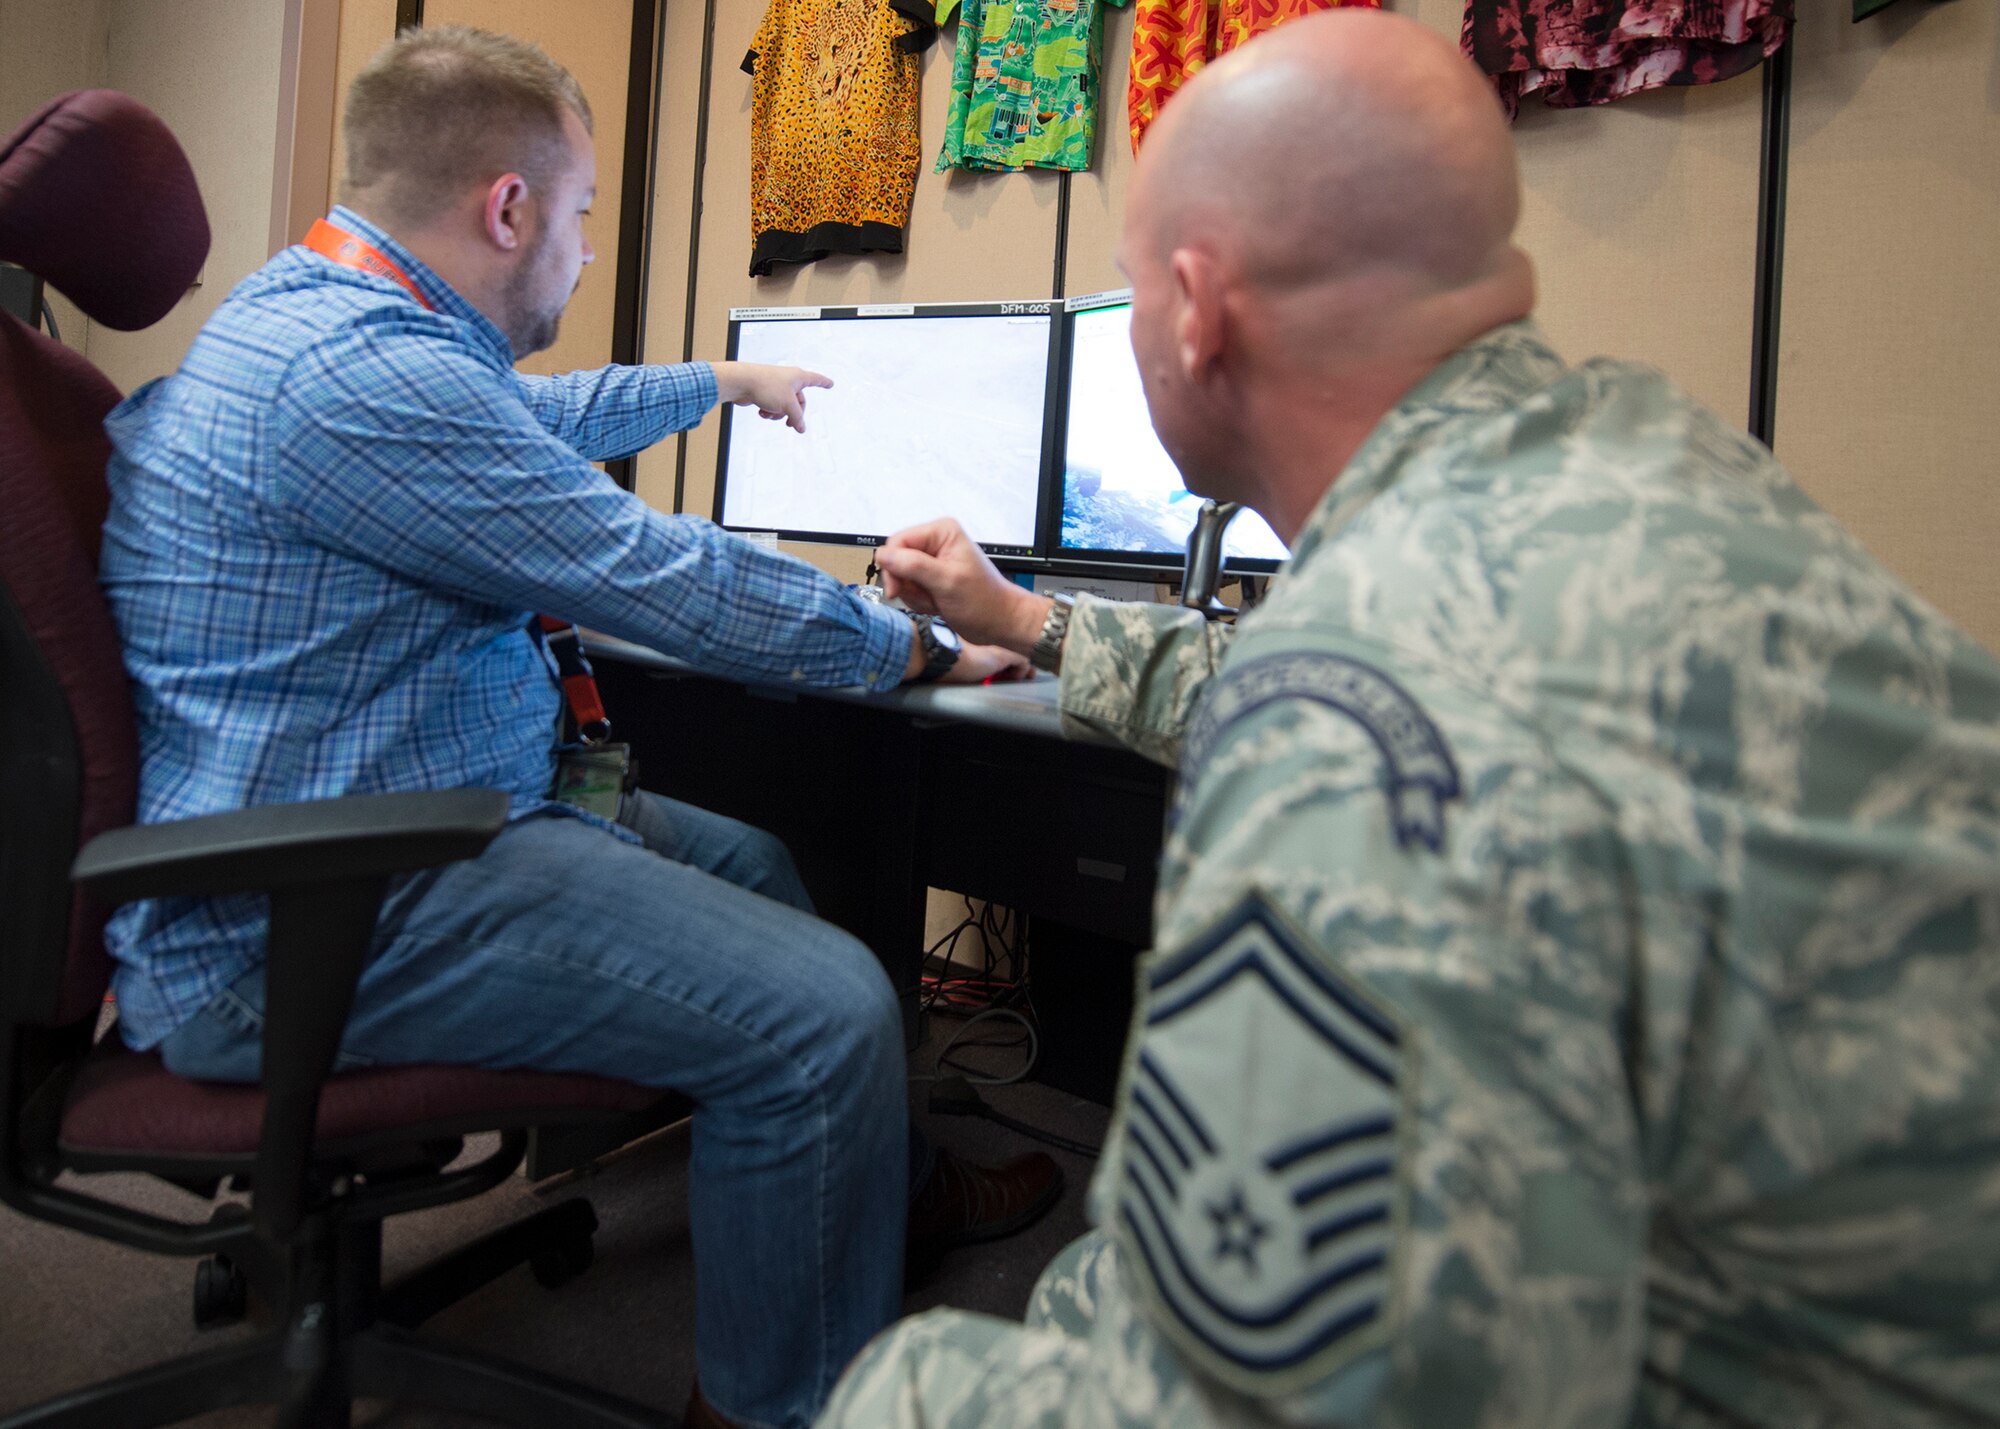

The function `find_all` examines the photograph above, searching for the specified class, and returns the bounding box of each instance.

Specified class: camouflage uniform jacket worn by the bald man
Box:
[1062,324,2000,1429]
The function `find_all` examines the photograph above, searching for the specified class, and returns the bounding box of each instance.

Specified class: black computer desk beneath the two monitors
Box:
[584,632,1170,1103]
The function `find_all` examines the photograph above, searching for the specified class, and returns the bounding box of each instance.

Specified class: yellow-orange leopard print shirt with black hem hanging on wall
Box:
[744,0,936,278]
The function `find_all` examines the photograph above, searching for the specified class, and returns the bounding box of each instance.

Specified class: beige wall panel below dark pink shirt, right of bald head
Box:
[1392,0,1764,426]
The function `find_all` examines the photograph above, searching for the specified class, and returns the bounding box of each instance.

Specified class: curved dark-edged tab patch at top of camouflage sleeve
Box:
[1180,650,1462,853]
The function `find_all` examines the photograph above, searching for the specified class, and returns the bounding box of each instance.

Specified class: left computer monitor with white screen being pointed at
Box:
[716,302,1054,556]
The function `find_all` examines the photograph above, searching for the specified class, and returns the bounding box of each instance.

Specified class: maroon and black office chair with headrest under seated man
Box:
[0,90,680,1429]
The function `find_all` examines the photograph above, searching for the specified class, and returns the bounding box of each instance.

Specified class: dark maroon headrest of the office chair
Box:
[0,90,208,330]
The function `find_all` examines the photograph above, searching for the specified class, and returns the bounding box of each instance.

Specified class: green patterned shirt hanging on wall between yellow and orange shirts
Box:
[916,0,1130,174]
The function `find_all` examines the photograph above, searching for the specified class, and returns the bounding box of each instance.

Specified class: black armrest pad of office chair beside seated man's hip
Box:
[70,789,508,903]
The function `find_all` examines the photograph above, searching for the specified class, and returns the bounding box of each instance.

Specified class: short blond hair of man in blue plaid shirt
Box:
[342,24,590,226]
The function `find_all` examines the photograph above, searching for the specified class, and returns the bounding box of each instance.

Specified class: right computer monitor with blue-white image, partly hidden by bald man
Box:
[1050,290,1288,574]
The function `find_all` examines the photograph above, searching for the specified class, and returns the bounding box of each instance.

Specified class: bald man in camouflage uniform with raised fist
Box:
[822,10,2000,1429]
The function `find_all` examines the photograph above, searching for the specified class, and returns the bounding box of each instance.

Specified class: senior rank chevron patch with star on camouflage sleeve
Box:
[1110,893,1416,1395]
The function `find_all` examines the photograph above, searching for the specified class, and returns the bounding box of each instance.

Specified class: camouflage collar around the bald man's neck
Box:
[1290,318,1564,568]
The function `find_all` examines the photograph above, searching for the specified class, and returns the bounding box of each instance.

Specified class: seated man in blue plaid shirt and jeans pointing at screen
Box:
[102,26,1058,1425]
